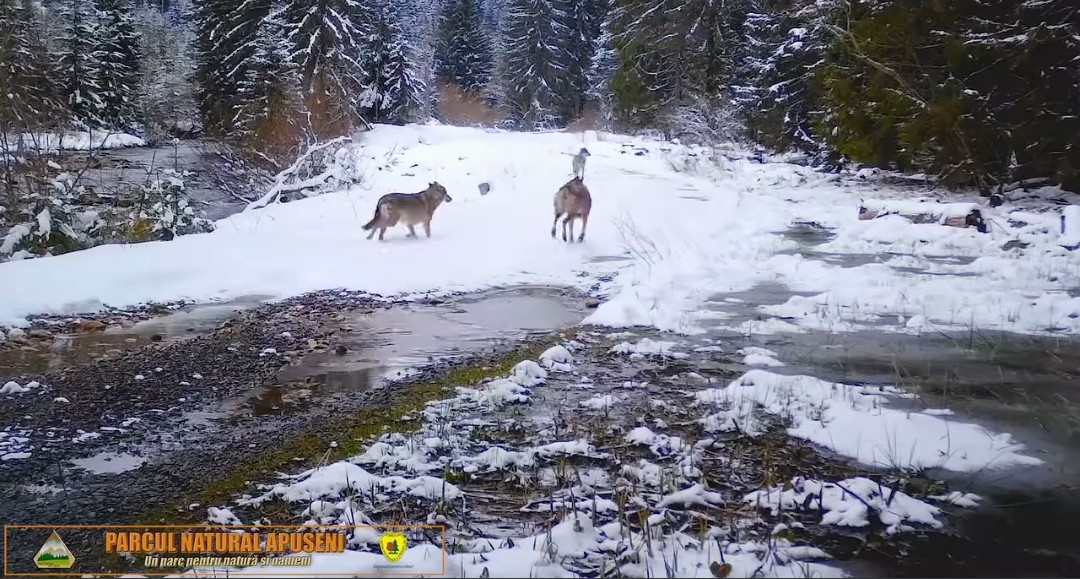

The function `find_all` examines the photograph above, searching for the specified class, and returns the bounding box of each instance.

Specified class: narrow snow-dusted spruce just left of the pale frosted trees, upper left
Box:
[96,0,142,129]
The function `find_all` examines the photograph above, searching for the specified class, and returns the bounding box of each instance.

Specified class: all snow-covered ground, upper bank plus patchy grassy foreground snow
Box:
[0,125,1080,577]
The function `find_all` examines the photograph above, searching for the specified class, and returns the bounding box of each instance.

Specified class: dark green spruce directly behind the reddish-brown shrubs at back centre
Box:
[435,0,492,92]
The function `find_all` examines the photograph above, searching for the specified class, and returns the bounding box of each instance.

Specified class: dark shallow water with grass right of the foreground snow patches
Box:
[706,272,1080,577]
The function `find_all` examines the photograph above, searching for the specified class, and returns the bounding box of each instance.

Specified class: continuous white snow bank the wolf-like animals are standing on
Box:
[0,125,1080,333]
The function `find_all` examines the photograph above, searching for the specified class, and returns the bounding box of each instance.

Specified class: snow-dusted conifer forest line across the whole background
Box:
[0,0,1080,192]
